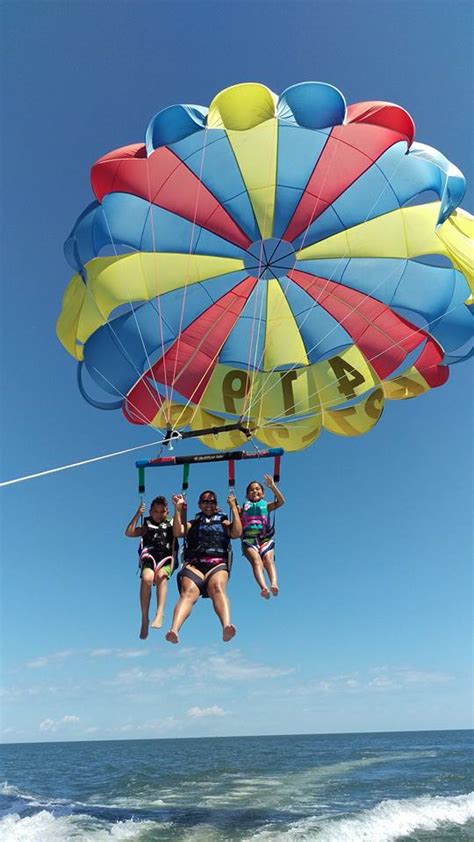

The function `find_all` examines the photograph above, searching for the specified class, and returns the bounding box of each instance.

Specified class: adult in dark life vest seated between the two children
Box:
[165,491,242,643]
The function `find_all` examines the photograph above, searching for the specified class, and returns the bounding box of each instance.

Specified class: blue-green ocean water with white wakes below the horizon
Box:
[0,731,474,842]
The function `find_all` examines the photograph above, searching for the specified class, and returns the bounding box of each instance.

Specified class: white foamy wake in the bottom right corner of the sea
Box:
[252,792,474,842]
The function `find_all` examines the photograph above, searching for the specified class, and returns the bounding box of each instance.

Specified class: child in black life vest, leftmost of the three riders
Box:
[125,497,178,640]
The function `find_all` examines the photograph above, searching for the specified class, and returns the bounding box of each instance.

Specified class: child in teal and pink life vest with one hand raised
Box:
[240,474,285,599]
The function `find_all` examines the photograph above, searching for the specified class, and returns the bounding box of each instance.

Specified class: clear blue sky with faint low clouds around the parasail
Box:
[0,0,473,742]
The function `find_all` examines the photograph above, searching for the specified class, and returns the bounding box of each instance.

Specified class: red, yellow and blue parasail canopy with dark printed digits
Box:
[57,82,473,450]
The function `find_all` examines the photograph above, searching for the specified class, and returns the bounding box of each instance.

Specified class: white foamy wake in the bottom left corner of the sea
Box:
[0,810,162,842]
